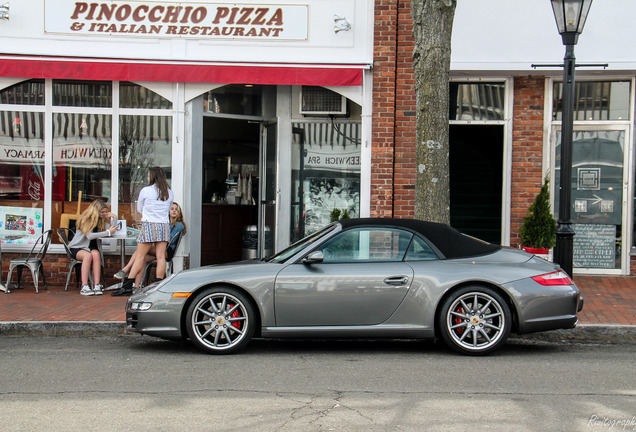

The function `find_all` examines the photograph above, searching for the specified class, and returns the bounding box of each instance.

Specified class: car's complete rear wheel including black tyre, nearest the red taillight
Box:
[438,286,511,355]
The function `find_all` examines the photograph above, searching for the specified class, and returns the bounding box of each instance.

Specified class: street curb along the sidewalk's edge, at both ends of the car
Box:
[0,321,636,342]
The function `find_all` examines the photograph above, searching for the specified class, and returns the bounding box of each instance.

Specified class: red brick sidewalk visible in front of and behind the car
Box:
[0,276,636,332]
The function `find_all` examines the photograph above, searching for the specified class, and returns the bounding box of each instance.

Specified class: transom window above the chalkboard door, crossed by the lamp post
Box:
[552,81,630,121]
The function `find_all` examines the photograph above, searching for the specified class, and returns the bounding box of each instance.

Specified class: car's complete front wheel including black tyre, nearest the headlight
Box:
[186,287,256,354]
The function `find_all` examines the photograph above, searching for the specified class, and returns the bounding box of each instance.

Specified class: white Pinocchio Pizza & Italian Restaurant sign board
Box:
[45,0,308,39]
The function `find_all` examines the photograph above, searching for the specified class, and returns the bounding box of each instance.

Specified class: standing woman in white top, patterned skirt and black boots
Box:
[112,167,174,296]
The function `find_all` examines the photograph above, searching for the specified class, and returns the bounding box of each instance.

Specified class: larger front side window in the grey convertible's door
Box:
[320,227,413,263]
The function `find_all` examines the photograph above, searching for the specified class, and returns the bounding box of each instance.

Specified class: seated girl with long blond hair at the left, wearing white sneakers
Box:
[68,199,117,296]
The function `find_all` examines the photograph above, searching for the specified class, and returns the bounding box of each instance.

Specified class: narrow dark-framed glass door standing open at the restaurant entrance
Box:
[258,119,279,258]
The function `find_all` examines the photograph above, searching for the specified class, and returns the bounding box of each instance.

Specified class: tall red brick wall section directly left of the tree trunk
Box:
[371,0,415,217]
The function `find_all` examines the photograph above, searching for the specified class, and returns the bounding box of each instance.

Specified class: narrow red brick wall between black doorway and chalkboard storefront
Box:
[510,76,545,246]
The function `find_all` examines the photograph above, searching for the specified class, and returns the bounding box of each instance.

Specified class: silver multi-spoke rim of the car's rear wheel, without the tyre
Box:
[446,291,508,351]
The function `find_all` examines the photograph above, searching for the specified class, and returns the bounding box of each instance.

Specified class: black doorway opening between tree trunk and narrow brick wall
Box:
[450,125,504,244]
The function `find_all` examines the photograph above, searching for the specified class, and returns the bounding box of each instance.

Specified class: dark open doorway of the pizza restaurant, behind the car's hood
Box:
[201,117,261,265]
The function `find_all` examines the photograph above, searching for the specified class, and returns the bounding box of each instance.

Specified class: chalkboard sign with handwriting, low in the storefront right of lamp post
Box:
[572,224,616,268]
